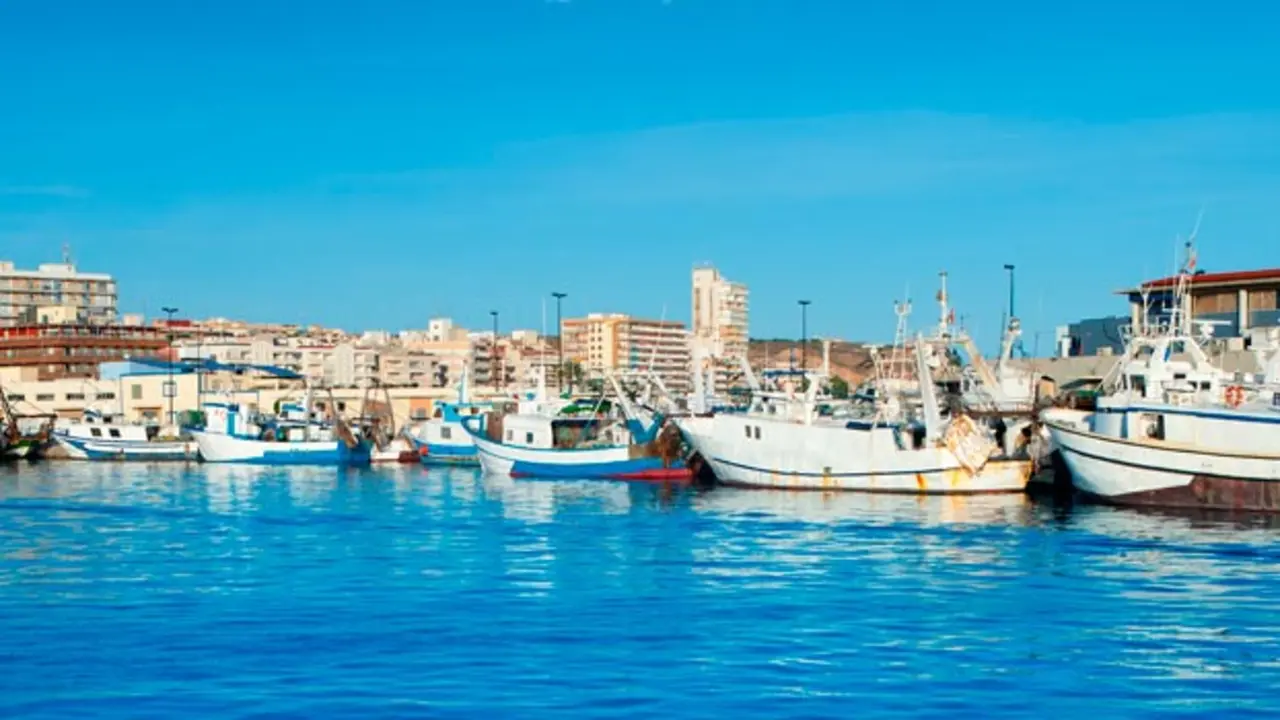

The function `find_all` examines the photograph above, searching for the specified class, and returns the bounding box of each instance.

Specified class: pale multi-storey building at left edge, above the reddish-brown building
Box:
[0,258,116,327]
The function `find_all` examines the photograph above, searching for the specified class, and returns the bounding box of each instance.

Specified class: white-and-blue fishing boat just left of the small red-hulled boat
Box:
[191,391,372,465]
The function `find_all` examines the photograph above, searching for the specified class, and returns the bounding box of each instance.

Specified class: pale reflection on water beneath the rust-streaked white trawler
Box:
[694,488,1037,525]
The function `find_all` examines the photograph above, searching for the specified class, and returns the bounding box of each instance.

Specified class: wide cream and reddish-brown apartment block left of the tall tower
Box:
[561,313,690,393]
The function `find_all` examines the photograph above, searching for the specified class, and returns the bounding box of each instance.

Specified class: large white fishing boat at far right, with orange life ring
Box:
[1042,245,1280,512]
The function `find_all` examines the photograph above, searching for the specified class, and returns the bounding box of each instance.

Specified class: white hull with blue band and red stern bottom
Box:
[472,427,692,482]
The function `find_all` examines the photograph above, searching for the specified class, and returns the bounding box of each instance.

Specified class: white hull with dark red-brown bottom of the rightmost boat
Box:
[1046,415,1280,512]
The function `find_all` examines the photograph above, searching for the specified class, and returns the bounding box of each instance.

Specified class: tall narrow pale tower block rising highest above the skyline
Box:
[691,268,750,386]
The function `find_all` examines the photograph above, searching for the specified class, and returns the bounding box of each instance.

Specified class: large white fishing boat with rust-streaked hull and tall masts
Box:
[677,283,1032,495]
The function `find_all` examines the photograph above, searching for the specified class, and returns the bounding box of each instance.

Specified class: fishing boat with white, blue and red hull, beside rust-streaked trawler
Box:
[462,374,692,482]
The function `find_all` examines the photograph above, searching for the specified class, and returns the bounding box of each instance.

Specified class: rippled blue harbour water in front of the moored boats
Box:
[0,462,1280,719]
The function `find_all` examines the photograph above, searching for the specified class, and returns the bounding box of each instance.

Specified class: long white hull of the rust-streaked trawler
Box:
[678,414,1032,495]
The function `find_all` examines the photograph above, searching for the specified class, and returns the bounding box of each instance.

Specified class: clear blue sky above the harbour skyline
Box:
[0,0,1280,350]
